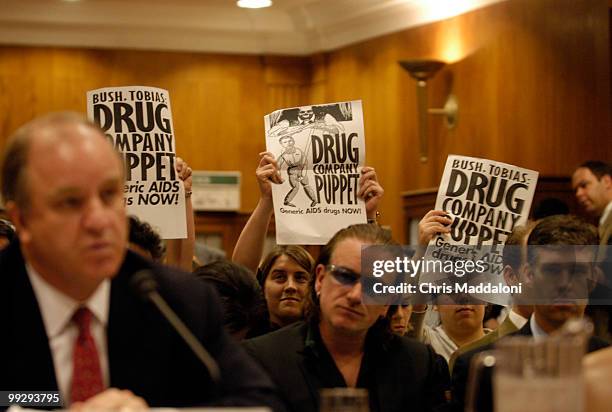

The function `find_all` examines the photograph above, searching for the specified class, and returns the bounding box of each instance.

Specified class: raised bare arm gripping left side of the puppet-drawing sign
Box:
[232,152,283,272]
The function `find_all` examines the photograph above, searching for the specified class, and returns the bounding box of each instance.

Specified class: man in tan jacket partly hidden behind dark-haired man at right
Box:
[448,222,535,373]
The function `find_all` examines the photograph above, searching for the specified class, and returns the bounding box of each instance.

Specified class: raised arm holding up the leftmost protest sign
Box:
[166,157,195,272]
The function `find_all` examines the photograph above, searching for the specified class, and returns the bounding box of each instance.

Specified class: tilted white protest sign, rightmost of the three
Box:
[421,155,538,304]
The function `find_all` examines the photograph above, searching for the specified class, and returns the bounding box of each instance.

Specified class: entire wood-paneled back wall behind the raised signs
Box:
[0,0,612,245]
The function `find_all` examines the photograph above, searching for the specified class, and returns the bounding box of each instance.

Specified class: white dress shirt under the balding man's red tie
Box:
[26,264,110,406]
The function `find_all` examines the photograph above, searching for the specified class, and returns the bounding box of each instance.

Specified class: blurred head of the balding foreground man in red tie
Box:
[9,124,127,300]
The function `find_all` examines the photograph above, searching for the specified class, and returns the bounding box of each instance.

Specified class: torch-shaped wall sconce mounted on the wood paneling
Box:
[399,60,459,163]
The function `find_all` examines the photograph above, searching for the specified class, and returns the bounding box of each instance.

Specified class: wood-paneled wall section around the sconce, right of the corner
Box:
[314,0,612,238]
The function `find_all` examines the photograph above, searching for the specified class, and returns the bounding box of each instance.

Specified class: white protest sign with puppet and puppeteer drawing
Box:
[264,101,367,245]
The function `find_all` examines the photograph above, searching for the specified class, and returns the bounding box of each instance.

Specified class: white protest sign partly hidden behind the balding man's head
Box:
[87,86,187,239]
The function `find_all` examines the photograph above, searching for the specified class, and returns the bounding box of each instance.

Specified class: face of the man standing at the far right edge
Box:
[572,167,612,215]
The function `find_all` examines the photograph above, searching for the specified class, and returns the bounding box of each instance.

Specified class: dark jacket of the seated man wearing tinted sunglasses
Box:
[244,322,449,412]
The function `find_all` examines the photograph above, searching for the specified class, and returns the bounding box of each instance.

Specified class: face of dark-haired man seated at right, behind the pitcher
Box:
[531,246,595,329]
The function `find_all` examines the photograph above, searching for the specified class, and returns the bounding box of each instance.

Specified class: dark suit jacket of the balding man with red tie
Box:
[0,242,284,409]
